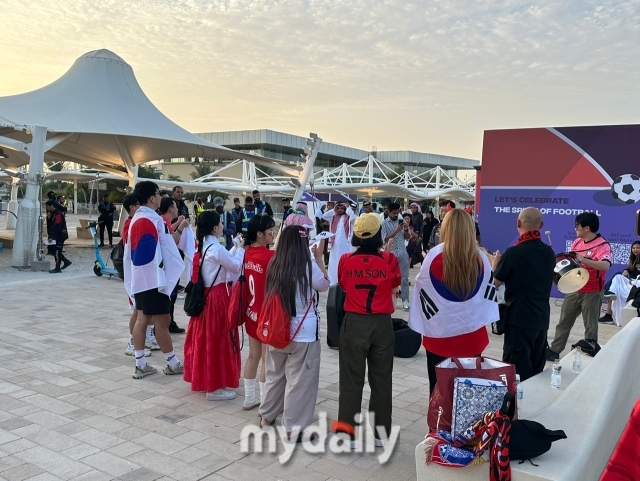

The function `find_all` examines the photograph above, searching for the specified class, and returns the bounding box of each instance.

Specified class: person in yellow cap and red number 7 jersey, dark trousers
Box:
[333,214,402,448]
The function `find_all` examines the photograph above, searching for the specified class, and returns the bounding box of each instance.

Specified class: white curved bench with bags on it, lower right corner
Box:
[415,317,640,481]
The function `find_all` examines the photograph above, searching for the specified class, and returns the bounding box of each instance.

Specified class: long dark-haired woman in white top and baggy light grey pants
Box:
[260,225,329,441]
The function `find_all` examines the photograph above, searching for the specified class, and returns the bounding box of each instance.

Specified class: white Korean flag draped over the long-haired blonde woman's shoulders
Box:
[409,244,500,338]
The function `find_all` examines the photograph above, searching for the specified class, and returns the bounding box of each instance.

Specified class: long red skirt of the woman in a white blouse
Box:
[184,283,241,392]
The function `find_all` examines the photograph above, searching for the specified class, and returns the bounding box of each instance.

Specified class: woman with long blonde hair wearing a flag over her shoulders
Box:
[409,209,499,392]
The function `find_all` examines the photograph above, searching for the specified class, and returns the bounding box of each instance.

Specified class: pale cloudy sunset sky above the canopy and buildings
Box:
[0,0,640,159]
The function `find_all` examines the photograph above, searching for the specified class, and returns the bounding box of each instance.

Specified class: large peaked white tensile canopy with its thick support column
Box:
[0,49,301,267]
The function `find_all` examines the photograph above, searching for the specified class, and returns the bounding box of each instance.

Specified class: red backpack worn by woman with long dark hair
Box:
[256,295,315,349]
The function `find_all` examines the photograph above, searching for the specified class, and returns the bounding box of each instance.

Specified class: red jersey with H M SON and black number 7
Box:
[338,251,402,314]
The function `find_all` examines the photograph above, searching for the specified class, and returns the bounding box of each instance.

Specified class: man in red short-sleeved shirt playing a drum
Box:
[547,212,611,361]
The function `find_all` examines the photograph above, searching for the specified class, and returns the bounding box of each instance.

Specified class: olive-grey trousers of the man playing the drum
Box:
[549,292,602,354]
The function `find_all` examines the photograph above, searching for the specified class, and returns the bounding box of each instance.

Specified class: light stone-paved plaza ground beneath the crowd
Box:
[0,215,618,481]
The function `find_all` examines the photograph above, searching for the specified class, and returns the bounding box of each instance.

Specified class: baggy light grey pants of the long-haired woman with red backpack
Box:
[260,341,320,432]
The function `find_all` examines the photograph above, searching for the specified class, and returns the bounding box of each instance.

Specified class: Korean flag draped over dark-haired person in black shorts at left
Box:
[123,206,184,297]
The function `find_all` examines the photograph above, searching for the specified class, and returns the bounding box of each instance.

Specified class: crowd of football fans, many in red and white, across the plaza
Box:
[46,177,640,446]
